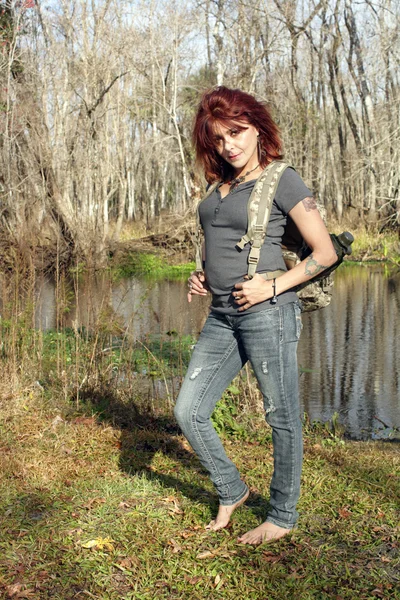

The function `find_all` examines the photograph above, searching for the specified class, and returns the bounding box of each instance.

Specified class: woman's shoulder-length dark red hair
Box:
[193,86,283,182]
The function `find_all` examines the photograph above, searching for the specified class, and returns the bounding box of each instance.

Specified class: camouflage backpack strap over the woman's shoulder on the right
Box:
[236,160,289,279]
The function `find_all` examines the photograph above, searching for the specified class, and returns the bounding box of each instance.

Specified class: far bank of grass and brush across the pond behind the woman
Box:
[0,215,400,279]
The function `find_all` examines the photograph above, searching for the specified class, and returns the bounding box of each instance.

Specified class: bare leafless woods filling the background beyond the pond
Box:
[0,0,400,265]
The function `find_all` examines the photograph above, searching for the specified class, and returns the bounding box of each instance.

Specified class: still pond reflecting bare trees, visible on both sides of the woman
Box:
[14,265,400,439]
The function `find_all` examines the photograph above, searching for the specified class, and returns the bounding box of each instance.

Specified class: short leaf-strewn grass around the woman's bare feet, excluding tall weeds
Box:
[0,386,400,600]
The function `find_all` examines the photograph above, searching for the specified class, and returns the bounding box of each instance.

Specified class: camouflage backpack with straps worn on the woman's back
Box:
[195,161,354,312]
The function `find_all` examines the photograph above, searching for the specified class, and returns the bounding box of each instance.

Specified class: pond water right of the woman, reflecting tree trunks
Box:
[299,267,400,437]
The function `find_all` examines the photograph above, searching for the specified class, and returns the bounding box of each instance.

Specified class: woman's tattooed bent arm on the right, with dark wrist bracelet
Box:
[233,198,337,311]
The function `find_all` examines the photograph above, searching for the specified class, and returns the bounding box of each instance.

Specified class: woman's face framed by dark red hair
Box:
[214,121,258,175]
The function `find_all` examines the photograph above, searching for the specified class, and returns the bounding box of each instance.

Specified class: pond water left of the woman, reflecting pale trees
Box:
[35,274,209,340]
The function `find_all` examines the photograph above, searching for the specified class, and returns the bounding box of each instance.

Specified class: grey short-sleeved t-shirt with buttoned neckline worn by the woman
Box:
[199,168,312,315]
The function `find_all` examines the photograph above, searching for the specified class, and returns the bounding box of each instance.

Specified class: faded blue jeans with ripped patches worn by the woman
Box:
[175,303,303,529]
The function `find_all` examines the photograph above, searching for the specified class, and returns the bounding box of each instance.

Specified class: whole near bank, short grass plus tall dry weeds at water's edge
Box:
[0,274,400,600]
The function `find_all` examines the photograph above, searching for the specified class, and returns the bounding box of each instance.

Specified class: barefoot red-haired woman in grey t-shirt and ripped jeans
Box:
[175,87,337,544]
